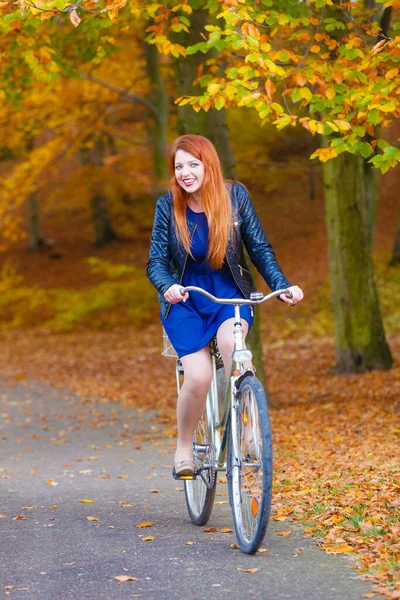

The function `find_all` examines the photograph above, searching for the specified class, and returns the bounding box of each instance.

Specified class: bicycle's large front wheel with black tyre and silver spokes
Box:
[227,375,272,554]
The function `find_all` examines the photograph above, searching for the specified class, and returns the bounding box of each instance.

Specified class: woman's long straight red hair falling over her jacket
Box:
[168,135,232,269]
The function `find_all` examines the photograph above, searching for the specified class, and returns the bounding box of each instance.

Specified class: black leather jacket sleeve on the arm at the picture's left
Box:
[146,196,176,296]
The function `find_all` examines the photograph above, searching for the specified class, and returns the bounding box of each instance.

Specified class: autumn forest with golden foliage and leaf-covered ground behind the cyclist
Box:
[0,0,400,598]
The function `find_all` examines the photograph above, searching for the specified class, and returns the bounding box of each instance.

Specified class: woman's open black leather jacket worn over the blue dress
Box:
[147,182,290,318]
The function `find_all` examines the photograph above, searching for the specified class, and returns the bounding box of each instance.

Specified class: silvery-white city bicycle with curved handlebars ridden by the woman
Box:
[167,286,291,554]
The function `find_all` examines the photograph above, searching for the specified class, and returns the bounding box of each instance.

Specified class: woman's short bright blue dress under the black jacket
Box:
[161,207,253,358]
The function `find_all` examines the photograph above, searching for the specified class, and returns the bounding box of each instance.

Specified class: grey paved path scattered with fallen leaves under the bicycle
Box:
[0,380,370,600]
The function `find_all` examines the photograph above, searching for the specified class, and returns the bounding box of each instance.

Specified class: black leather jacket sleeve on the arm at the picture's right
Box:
[235,183,290,292]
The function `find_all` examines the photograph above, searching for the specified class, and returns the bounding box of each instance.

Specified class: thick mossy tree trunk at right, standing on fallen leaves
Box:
[324,153,393,373]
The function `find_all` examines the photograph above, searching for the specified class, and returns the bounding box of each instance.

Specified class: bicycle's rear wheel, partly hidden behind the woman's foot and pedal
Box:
[184,409,217,525]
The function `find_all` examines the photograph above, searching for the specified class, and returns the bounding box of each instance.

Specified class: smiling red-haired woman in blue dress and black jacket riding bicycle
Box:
[147,135,303,476]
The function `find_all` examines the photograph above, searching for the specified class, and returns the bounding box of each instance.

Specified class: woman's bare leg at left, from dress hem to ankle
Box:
[175,346,212,463]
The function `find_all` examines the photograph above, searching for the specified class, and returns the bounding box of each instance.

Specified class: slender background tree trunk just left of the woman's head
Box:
[145,44,169,198]
